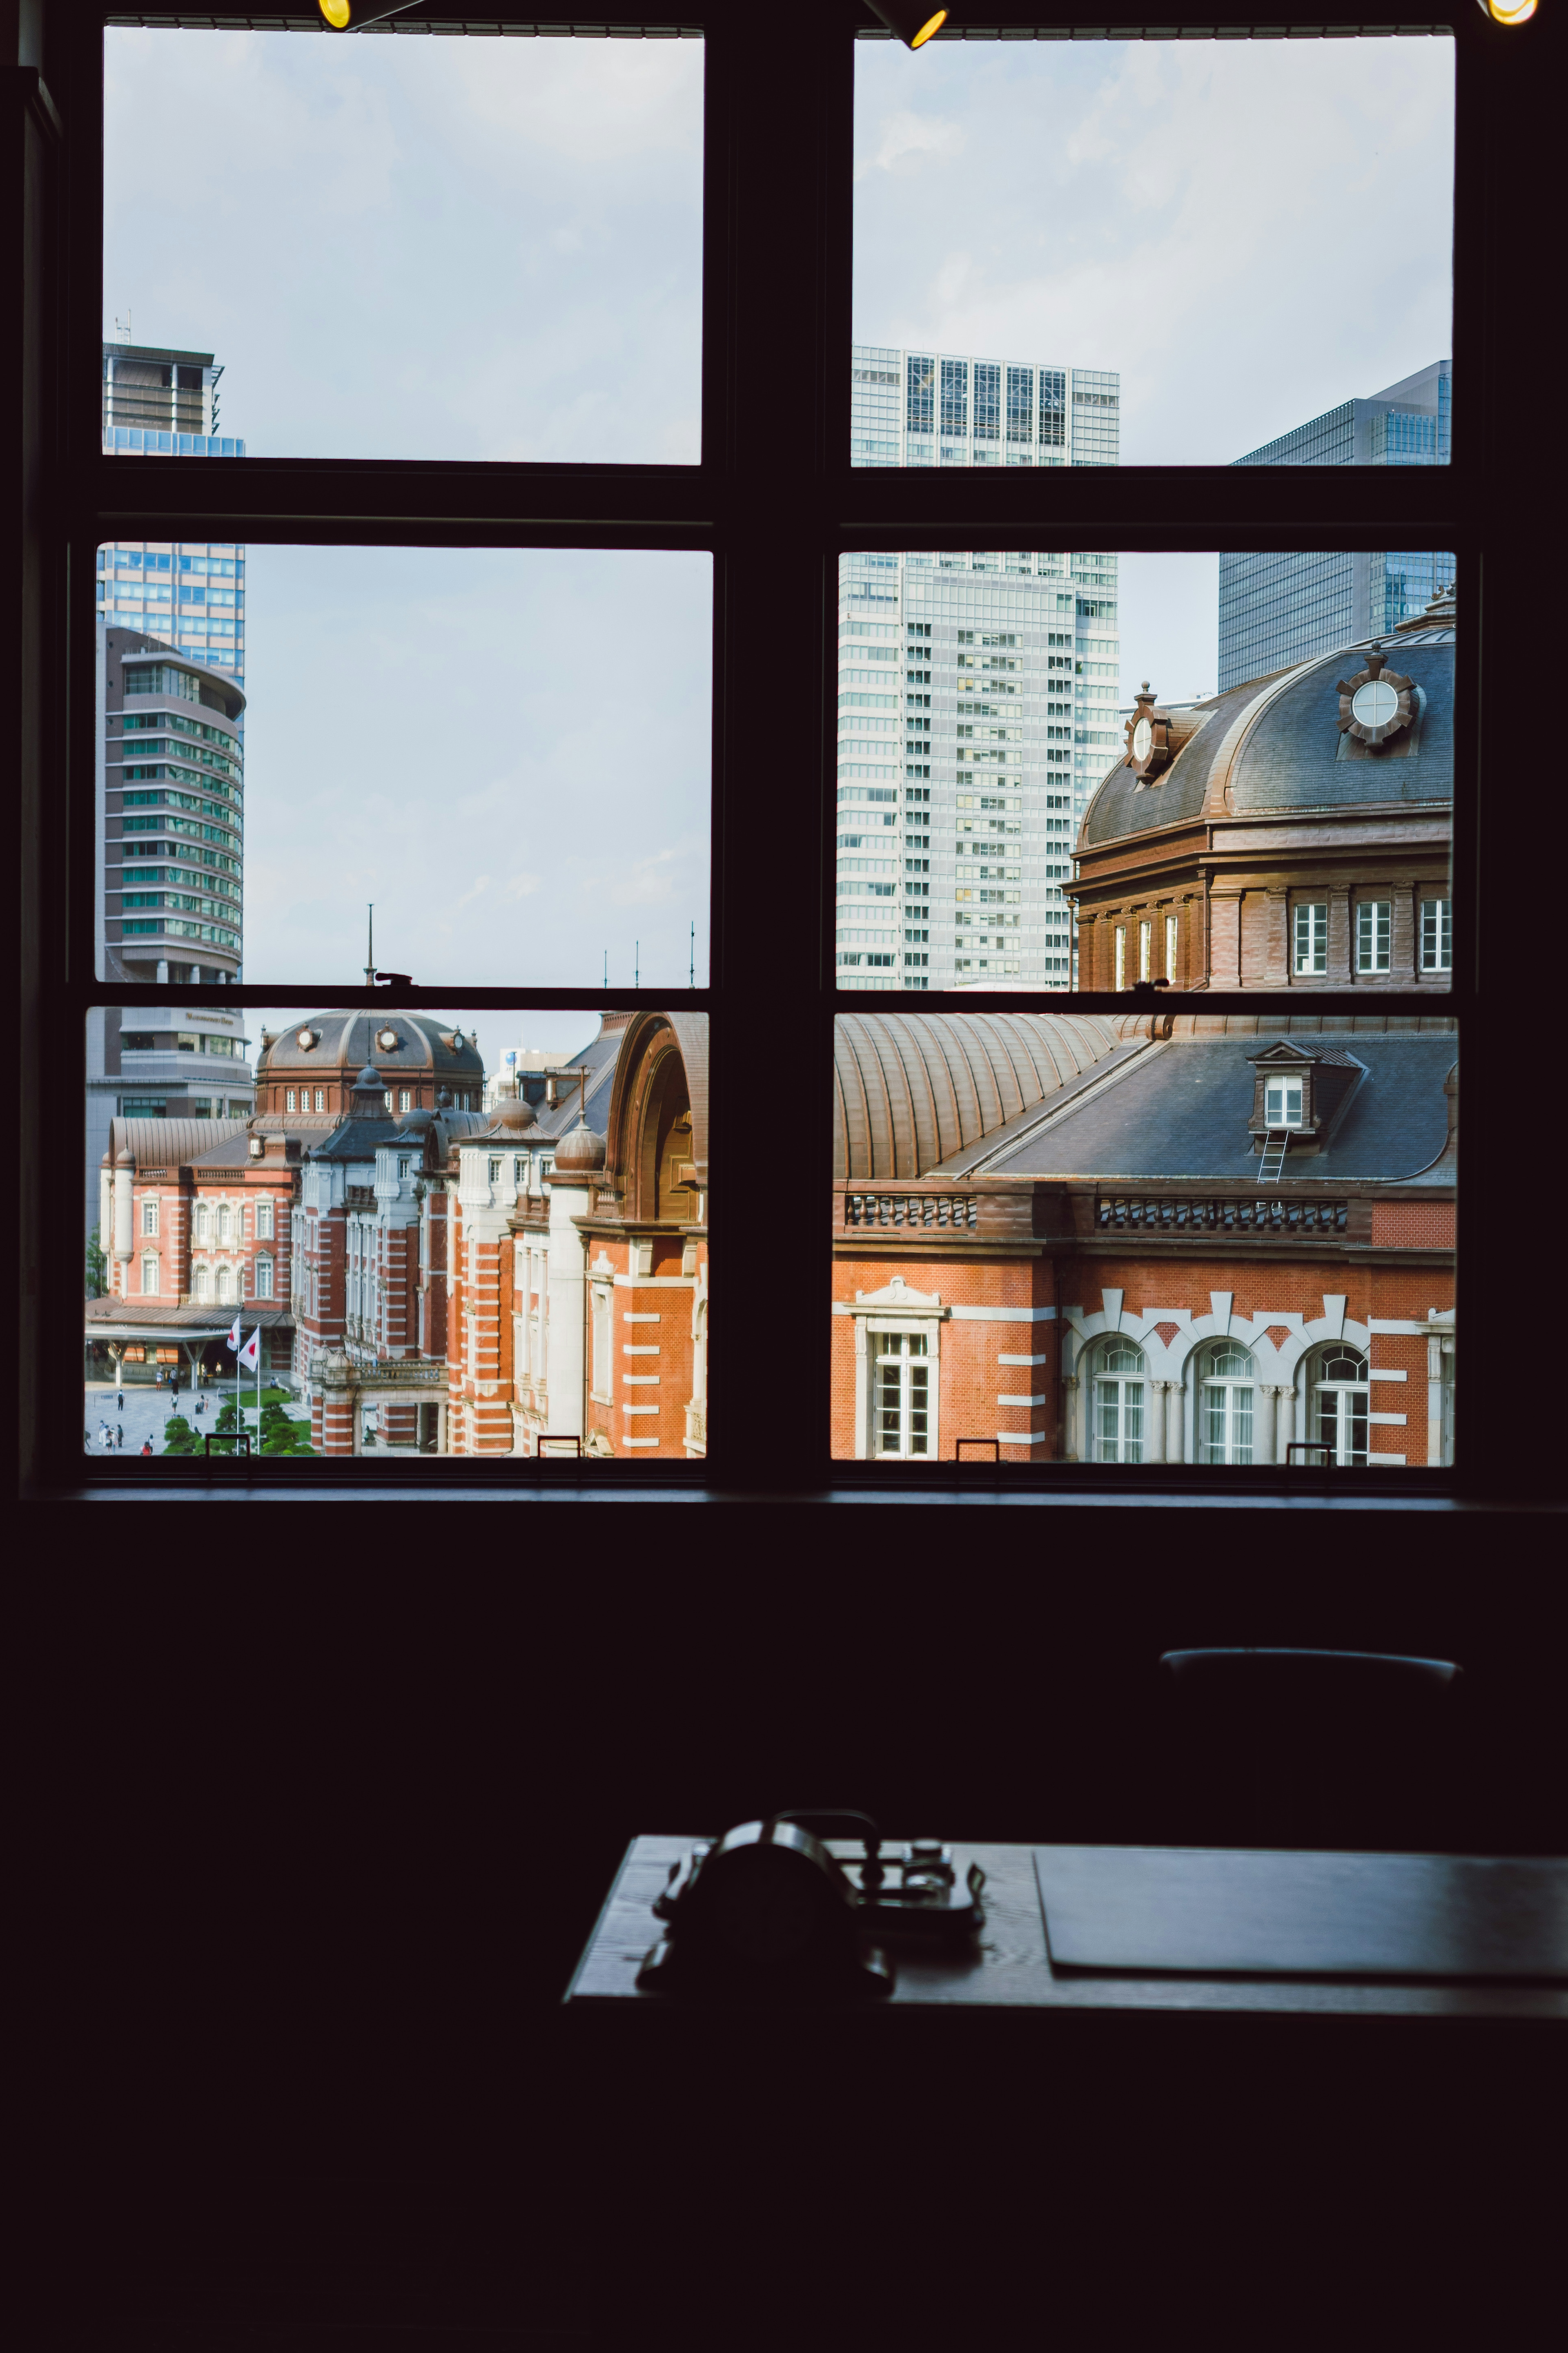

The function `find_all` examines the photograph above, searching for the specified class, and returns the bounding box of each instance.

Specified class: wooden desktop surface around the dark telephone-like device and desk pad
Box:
[566,1836,1568,2019]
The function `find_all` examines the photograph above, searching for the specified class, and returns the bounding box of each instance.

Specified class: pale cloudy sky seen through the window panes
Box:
[103,28,1453,1045]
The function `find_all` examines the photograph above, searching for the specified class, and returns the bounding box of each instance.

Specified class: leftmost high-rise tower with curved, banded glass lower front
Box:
[87,343,254,1231]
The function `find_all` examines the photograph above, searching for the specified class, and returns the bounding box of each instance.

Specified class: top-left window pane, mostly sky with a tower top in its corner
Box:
[103,26,703,464]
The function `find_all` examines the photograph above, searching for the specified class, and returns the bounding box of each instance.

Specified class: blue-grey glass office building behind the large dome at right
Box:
[1220,360,1455,694]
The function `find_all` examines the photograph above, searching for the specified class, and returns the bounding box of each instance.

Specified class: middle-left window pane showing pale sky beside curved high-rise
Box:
[99,544,712,988]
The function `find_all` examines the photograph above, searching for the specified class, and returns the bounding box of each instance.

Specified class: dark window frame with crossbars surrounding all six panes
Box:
[9,0,1561,1503]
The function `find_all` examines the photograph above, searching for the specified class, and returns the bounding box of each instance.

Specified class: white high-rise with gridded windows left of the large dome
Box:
[837,343,1121,988]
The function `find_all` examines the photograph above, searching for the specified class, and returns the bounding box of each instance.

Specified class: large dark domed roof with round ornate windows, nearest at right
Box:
[1079,602,1455,850]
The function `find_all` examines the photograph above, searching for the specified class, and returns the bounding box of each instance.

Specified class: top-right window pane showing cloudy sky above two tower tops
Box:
[851,38,1453,466]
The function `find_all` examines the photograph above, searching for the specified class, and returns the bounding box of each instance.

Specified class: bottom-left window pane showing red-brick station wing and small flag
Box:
[82,998,705,1461]
